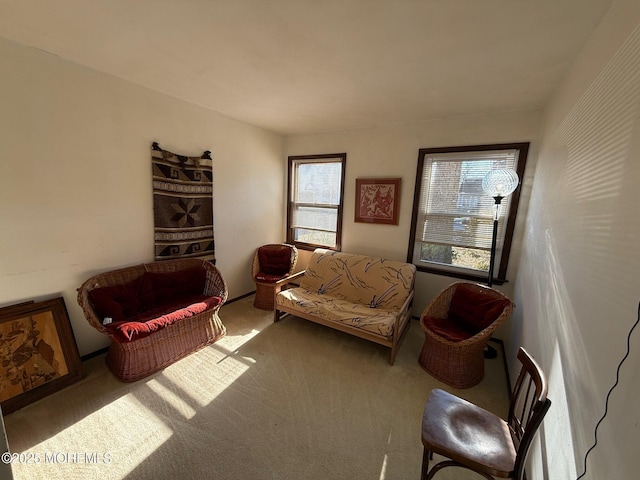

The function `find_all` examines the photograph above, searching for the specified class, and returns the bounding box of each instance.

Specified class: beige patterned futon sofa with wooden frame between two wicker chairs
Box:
[274,249,416,365]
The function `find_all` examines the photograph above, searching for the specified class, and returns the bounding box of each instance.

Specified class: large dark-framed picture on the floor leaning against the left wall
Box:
[0,297,82,414]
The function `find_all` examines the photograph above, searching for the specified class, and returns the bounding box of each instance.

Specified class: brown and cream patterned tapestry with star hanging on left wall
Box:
[151,142,215,264]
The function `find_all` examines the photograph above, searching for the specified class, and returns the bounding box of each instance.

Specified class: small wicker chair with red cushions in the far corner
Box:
[251,243,298,310]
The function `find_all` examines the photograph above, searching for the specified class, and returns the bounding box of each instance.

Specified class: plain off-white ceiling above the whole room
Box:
[0,0,612,135]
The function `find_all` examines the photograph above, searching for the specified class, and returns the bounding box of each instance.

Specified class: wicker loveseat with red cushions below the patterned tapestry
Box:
[78,259,228,381]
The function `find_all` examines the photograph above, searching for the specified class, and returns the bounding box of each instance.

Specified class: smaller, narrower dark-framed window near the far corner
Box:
[287,153,347,250]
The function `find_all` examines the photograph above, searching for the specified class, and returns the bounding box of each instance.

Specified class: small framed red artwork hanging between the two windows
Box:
[355,178,401,225]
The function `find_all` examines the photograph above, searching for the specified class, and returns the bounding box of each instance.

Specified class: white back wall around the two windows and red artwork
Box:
[285,111,541,316]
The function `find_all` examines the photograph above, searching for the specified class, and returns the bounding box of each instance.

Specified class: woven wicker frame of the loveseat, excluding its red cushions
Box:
[78,259,228,382]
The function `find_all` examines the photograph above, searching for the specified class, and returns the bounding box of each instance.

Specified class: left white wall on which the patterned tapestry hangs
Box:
[0,39,286,355]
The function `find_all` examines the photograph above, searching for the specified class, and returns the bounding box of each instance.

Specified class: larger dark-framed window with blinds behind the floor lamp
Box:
[407,143,529,284]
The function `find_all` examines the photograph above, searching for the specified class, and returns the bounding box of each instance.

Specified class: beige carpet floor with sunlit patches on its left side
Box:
[5,297,507,480]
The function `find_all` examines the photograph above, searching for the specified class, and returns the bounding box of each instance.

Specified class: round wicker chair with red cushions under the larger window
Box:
[419,282,514,388]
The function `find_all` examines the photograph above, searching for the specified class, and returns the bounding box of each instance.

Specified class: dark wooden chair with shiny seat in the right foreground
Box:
[421,348,551,480]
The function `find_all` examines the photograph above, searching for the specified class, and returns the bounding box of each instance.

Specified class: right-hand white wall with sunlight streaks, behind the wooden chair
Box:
[509,0,640,480]
